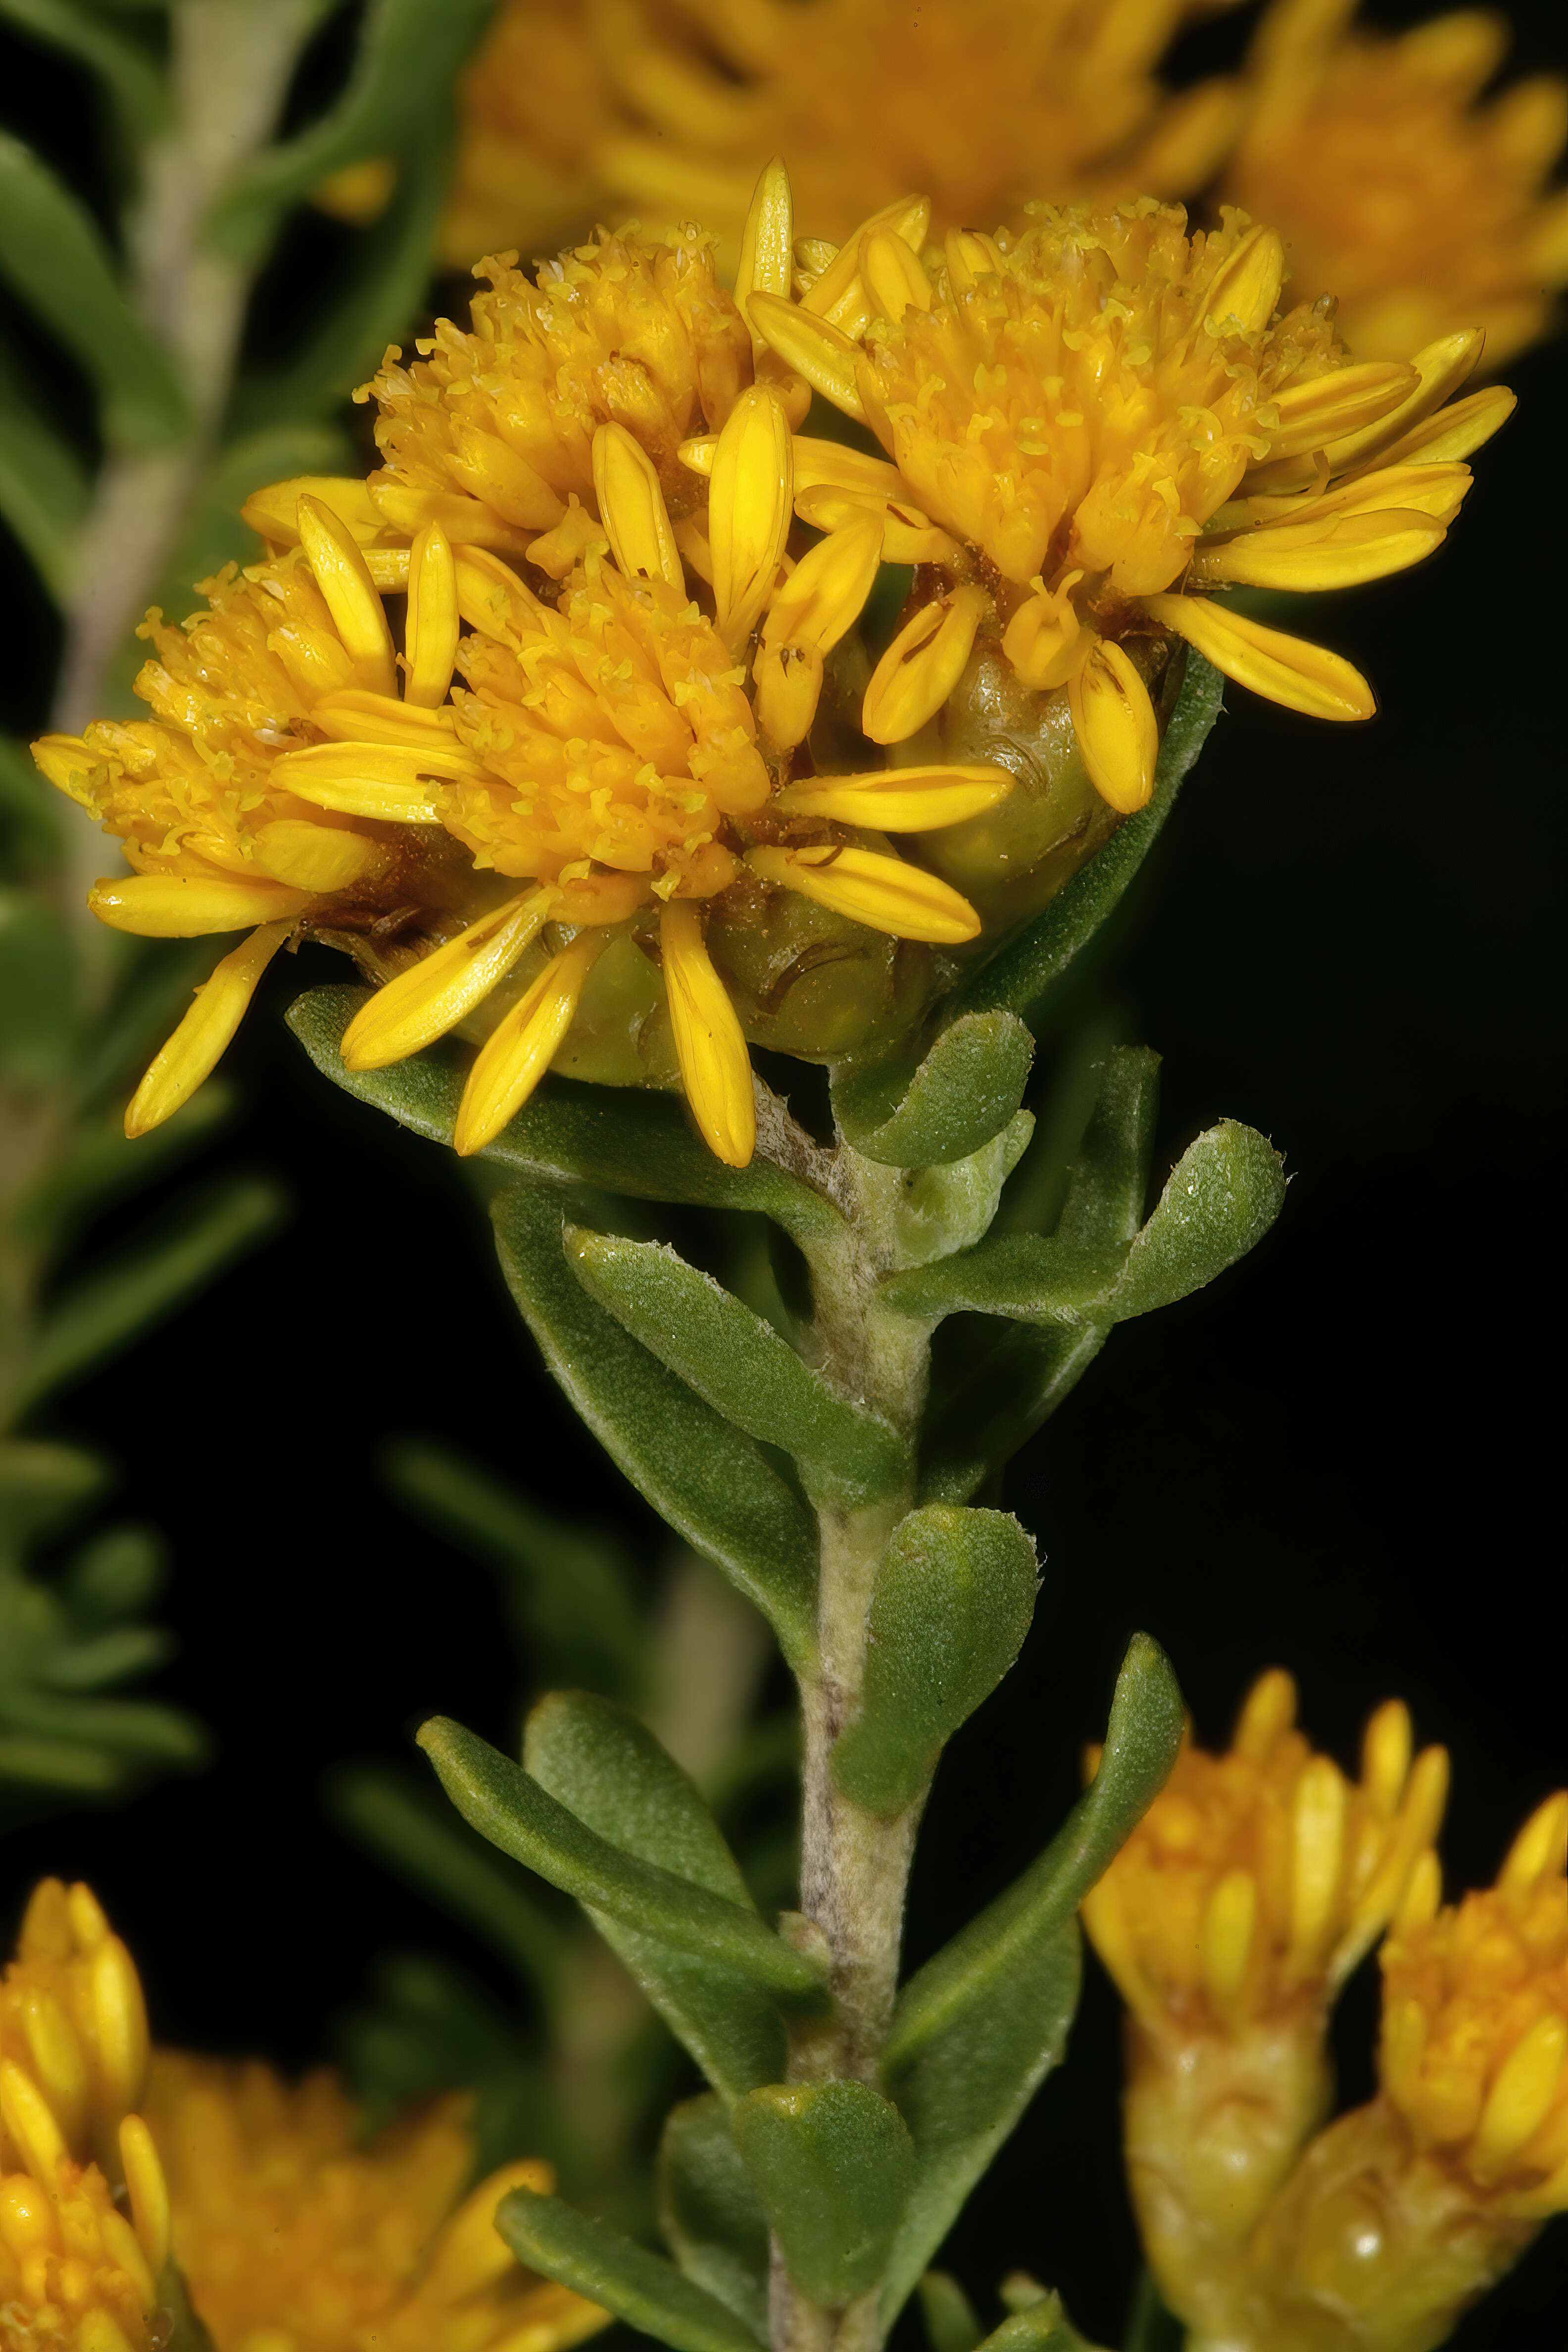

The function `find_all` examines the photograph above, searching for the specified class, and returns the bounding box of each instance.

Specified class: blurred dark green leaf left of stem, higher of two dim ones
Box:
[383,1437,646,1698]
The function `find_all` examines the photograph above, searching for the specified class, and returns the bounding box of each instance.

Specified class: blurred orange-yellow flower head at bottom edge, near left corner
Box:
[148,2051,606,2352]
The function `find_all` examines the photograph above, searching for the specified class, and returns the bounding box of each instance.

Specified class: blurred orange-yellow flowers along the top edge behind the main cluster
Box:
[324,0,1568,369]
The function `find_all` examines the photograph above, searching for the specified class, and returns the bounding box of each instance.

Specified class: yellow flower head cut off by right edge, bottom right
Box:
[1380,1792,1568,2220]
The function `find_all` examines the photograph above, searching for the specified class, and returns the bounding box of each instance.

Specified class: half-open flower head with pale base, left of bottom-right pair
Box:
[1084,1672,1448,2326]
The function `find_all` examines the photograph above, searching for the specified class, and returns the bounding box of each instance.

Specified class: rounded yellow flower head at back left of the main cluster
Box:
[362,228,752,555]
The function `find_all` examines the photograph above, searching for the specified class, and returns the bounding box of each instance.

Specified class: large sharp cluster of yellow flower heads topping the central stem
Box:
[38,165,1509,1167]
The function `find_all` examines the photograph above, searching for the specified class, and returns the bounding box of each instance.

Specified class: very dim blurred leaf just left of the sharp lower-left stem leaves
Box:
[327,1764,567,1990]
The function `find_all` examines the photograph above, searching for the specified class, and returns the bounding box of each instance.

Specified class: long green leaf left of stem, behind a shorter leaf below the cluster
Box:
[493,1190,816,1672]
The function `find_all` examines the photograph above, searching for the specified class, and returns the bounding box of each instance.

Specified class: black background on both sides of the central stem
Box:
[4,0,1568,2352]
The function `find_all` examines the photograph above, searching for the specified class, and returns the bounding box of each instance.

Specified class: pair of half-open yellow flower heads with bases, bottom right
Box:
[1084,1672,1568,2352]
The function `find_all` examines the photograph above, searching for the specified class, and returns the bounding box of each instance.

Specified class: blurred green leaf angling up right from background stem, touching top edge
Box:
[207,0,493,261]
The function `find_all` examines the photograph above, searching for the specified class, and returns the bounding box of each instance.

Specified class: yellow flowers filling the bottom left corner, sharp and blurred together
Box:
[0,1879,604,2352]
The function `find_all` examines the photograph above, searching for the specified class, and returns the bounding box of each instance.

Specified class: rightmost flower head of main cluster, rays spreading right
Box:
[747,179,1512,811]
